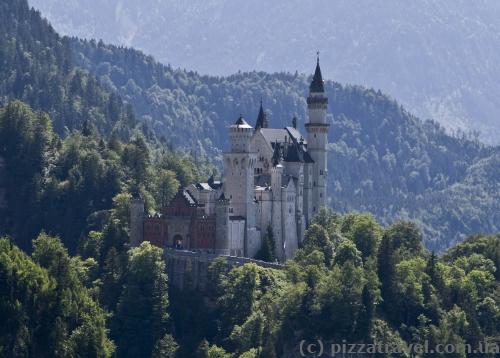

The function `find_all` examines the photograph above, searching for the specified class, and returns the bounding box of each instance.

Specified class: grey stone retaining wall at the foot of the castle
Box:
[164,249,283,292]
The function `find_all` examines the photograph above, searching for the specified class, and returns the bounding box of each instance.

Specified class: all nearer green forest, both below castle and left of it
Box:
[0,102,500,358]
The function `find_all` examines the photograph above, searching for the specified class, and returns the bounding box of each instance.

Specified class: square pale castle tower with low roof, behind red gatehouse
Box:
[224,116,259,256]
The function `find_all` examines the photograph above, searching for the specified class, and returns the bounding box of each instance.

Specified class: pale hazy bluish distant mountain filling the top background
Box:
[32,0,500,143]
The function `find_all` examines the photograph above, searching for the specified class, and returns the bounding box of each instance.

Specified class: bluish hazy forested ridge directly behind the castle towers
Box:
[71,39,500,250]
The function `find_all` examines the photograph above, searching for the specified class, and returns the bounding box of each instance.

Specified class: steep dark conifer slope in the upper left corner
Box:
[0,0,134,134]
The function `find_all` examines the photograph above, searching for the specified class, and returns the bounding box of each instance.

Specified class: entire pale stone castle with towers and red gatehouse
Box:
[130,59,329,261]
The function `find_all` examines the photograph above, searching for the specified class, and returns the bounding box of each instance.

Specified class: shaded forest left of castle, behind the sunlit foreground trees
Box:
[0,101,209,253]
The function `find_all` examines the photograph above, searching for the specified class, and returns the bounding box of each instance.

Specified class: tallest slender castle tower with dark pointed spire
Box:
[306,55,330,214]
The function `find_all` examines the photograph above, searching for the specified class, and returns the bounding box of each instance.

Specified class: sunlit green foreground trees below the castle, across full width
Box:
[0,206,500,358]
